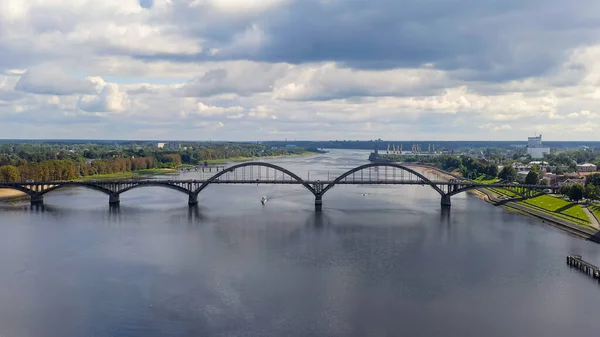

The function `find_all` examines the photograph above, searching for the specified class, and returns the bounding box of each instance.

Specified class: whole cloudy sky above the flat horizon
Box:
[0,0,600,141]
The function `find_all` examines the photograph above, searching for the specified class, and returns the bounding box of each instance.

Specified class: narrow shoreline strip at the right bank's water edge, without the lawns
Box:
[406,164,600,243]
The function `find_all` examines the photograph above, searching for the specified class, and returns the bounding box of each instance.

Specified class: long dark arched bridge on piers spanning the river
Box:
[0,162,559,209]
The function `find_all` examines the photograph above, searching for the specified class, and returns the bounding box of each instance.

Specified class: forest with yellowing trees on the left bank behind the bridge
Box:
[0,142,305,182]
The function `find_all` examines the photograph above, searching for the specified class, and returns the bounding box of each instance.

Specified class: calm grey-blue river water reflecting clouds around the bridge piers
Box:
[0,150,600,337]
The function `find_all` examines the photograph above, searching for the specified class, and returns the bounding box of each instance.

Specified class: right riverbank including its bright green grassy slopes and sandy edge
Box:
[406,165,600,242]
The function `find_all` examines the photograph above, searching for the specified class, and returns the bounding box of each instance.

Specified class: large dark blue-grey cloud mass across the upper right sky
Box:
[131,0,600,81]
